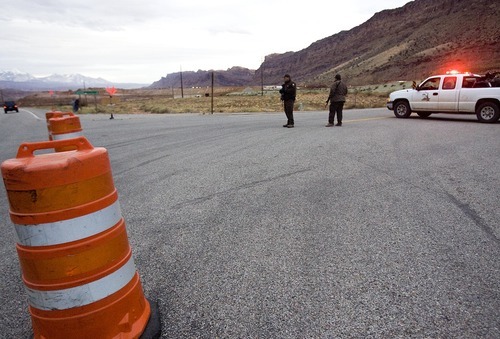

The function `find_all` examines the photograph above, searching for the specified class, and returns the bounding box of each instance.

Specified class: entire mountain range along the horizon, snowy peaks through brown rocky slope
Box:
[0,0,500,90]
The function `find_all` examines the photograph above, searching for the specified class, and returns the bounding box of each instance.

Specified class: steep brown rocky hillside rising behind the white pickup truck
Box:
[253,0,500,85]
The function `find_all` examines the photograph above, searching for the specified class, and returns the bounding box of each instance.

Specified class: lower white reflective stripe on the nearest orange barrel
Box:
[26,256,136,311]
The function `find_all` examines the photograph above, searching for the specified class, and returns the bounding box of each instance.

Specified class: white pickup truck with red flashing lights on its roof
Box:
[387,73,500,123]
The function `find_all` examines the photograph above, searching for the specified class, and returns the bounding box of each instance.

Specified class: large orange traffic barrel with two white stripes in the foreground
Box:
[1,137,158,339]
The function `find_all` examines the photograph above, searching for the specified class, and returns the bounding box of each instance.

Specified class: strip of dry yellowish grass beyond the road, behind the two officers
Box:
[19,83,403,114]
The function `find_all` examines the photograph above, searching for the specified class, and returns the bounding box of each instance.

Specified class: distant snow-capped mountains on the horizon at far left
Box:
[0,70,146,91]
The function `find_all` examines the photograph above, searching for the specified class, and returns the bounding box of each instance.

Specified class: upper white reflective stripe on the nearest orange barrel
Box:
[15,200,122,246]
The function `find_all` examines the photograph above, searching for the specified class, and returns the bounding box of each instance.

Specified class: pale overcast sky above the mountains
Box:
[0,0,411,84]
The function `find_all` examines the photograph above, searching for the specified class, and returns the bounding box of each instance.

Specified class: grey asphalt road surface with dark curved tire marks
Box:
[0,109,500,338]
